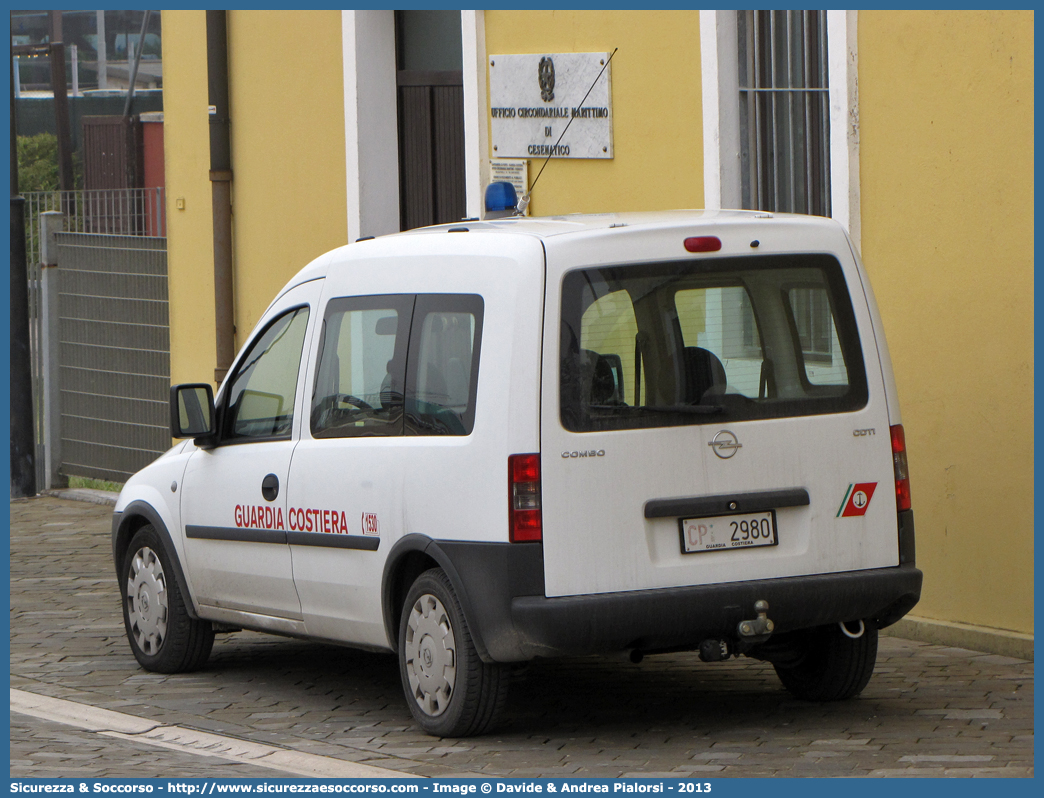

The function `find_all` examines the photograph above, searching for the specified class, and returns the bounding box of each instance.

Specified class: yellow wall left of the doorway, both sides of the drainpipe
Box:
[163,10,348,382]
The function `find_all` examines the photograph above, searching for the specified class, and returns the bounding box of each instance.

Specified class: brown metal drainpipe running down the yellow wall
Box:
[207,11,236,383]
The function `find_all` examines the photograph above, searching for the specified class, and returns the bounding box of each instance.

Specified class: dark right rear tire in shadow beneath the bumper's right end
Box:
[775,623,877,701]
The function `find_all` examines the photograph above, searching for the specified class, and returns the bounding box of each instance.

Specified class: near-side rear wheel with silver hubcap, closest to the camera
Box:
[399,568,508,737]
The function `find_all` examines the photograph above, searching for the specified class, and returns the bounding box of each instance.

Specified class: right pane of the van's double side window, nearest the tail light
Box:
[405,294,482,436]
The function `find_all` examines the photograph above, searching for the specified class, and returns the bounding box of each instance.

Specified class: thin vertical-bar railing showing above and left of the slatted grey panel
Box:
[24,188,169,486]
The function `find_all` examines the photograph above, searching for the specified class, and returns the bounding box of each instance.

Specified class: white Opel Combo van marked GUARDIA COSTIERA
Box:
[113,211,921,736]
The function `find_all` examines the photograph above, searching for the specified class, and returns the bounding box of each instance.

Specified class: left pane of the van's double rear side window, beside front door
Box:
[311,295,413,438]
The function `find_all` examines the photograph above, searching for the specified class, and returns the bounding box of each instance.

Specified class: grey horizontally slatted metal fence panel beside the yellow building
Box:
[56,233,170,483]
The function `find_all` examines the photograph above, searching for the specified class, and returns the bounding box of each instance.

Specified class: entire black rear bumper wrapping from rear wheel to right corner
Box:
[432,534,922,662]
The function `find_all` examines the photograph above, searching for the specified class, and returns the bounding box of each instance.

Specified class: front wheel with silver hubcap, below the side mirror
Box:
[120,525,214,674]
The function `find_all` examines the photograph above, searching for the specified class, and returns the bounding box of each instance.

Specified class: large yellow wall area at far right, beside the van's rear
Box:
[858,11,1034,633]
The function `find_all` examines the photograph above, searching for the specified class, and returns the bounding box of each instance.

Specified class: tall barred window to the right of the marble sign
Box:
[736,10,830,216]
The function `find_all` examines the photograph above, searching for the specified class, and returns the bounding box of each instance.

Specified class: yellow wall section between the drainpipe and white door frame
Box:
[229,10,348,346]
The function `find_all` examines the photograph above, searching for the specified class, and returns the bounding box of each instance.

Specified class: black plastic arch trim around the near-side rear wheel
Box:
[381,535,494,662]
